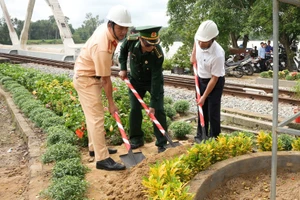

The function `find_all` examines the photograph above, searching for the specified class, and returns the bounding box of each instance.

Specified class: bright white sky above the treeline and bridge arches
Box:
[2,0,169,29]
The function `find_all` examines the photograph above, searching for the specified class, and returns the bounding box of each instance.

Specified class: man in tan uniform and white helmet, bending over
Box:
[73,5,132,170]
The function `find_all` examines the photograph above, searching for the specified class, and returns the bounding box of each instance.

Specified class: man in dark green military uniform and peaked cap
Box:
[119,26,167,153]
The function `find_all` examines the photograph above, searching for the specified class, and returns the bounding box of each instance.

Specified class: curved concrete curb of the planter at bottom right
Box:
[189,151,300,200]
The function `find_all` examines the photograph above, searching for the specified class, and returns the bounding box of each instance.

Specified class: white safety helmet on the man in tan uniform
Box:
[106,5,132,27]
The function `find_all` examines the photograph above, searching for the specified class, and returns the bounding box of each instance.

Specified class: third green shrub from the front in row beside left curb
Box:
[42,143,80,163]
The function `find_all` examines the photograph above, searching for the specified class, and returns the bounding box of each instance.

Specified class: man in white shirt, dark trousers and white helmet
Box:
[190,20,225,143]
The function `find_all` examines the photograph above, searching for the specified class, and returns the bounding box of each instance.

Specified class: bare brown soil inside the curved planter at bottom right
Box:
[205,169,300,200]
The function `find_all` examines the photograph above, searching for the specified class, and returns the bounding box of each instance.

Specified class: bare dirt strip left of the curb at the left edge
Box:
[0,96,29,200]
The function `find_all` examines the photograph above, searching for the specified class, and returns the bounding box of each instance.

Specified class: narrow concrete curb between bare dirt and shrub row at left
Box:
[0,86,44,199]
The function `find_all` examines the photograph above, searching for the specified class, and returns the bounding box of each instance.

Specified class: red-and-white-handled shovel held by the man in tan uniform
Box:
[114,112,145,168]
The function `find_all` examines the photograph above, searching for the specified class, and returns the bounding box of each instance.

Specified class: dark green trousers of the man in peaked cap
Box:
[129,80,167,147]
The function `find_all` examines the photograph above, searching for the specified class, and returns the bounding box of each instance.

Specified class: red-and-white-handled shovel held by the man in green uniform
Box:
[124,78,181,147]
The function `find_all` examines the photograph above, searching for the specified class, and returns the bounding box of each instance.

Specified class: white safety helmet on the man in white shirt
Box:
[195,20,219,42]
